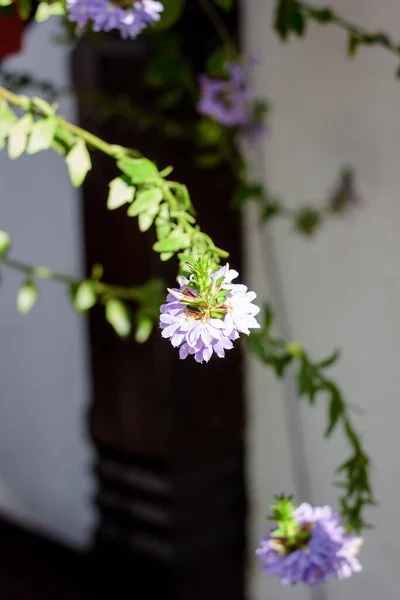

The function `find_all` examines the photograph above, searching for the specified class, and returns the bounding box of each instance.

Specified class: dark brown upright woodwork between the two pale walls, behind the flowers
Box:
[73,8,246,600]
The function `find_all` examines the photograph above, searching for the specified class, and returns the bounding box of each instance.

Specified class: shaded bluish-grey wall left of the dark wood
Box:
[0,20,93,547]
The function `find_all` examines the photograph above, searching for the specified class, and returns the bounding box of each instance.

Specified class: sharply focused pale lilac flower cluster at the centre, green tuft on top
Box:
[160,259,260,363]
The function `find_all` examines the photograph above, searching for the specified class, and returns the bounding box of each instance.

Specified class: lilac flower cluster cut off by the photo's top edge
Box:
[67,0,164,38]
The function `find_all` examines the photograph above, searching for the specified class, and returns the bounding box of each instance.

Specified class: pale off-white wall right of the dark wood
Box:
[243,0,400,600]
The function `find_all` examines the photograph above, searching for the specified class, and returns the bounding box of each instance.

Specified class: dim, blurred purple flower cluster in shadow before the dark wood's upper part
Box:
[197,63,263,139]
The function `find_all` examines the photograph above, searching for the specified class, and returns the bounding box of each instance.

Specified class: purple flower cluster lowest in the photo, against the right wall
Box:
[256,503,362,587]
